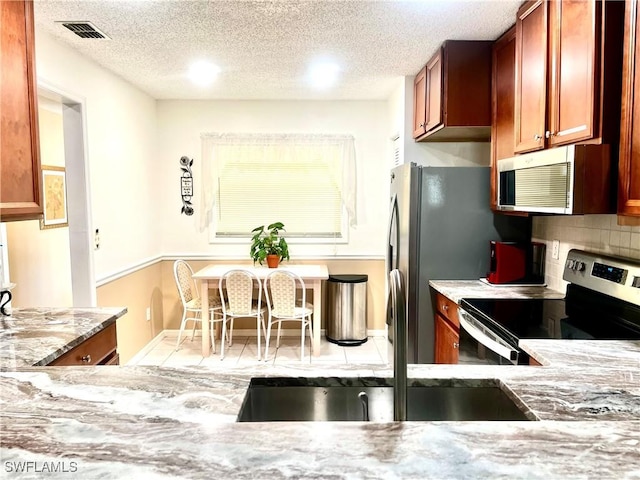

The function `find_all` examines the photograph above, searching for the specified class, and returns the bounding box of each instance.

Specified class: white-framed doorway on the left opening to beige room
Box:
[0,82,97,307]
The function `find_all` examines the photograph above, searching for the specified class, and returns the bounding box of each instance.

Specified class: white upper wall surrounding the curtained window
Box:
[155,100,391,261]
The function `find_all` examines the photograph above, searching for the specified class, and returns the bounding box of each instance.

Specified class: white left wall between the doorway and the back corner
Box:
[36,31,162,280]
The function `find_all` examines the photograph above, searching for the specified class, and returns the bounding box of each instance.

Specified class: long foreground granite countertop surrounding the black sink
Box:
[0,308,640,480]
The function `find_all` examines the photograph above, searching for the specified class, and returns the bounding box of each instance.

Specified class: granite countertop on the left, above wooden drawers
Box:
[0,307,127,371]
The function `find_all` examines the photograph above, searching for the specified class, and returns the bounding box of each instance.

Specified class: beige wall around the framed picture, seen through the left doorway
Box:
[6,101,73,307]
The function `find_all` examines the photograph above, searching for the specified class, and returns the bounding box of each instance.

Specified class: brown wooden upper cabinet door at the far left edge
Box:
[0,1,42,221]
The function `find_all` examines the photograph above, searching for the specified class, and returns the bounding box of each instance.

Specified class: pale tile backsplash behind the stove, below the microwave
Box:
[532,215,640,292]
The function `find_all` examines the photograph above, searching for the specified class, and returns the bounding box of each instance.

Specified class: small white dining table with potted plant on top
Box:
[193,264,329,357]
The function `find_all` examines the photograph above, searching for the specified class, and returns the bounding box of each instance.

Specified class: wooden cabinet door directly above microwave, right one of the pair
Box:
[545,0,601,145]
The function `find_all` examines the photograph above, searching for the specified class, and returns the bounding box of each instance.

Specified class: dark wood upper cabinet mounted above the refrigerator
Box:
[413,40,493,141]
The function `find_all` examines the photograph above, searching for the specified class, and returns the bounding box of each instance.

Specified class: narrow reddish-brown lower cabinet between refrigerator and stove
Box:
[434,293,460,364]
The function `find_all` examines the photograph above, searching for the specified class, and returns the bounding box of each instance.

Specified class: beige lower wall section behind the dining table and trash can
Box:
[162,259,386,330]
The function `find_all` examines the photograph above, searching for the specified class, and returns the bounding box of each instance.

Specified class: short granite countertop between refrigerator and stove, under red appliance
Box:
[429,280,565,303]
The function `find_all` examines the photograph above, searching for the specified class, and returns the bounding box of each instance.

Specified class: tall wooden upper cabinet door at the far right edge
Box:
[618,0,640,216]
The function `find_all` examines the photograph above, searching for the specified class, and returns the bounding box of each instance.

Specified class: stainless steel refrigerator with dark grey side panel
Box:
[387,163,531,363]
